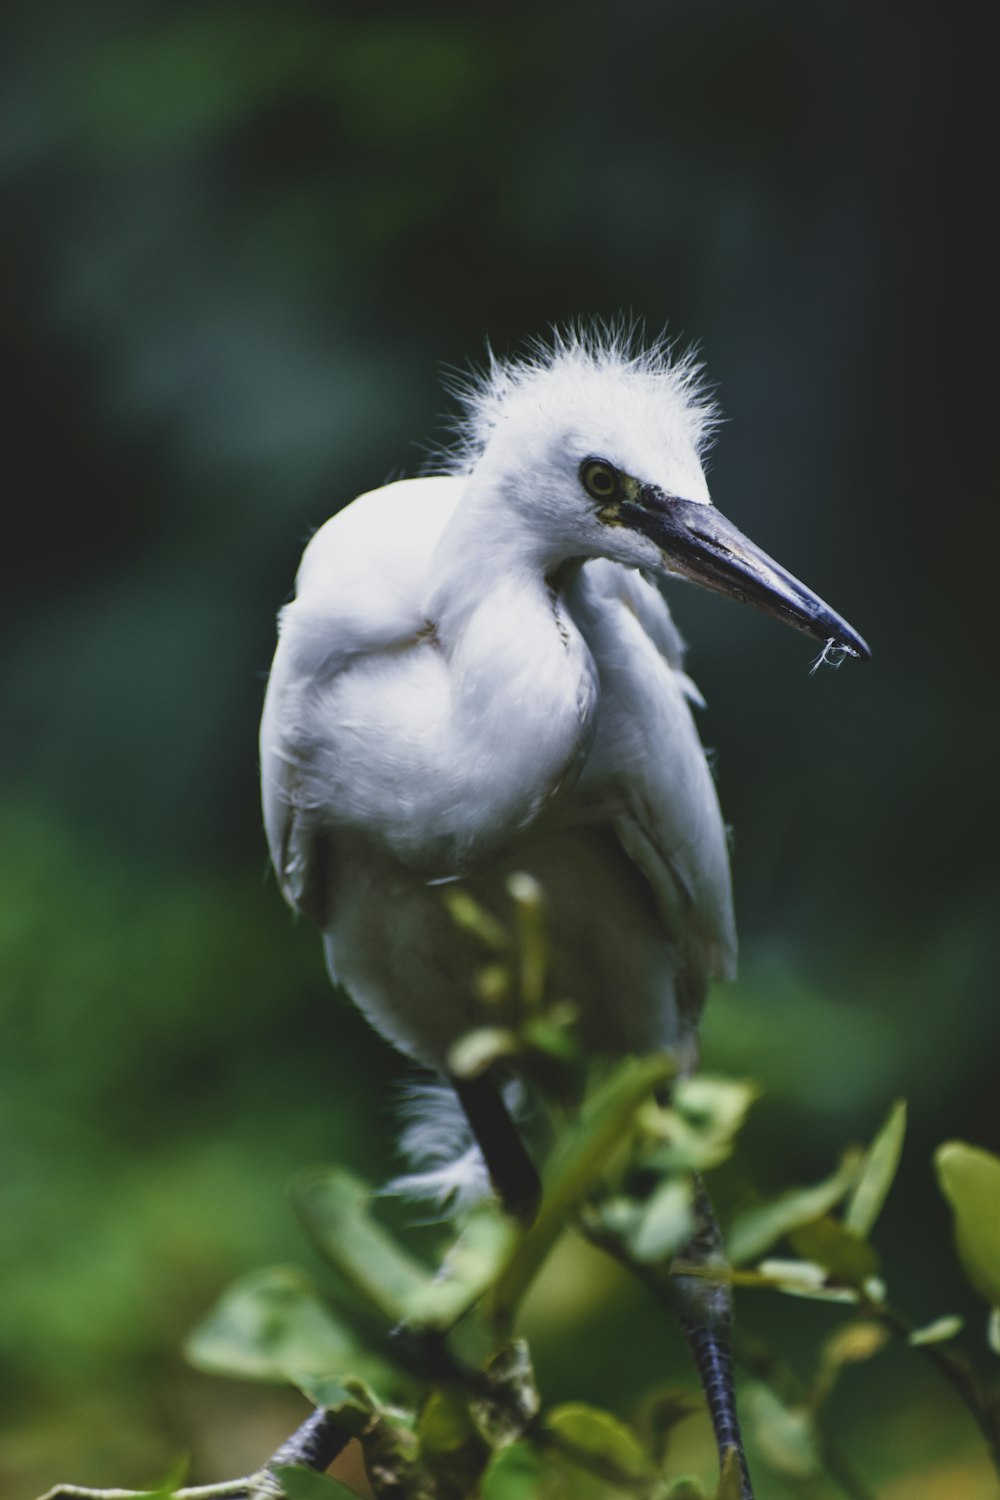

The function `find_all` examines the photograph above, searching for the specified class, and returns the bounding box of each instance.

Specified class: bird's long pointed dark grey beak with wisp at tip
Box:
[616,485,871,662]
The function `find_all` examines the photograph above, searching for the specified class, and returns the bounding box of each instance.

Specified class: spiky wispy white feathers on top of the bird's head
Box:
[441,320,720,474]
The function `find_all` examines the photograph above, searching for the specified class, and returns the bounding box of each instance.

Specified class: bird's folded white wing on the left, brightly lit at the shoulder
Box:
[259,479,462,923]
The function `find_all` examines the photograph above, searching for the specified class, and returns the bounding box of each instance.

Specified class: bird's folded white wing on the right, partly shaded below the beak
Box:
[570,560,736,1011]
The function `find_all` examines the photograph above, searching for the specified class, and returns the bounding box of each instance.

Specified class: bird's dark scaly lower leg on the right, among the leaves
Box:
[670,1179,754,1500]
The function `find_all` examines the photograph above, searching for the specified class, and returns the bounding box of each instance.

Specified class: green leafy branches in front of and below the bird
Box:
[35,878,1000,1500]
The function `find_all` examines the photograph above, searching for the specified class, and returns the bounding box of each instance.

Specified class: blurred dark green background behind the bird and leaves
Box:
[0,0,1000,1500]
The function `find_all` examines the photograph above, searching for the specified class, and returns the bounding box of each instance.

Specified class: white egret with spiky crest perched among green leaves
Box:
[261,333,870,1494]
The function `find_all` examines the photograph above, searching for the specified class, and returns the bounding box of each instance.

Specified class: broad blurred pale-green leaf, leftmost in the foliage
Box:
[186,1266,358,1385]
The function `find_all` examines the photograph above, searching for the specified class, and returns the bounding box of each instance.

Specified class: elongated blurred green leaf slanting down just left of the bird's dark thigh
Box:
[292,1169,432,1323]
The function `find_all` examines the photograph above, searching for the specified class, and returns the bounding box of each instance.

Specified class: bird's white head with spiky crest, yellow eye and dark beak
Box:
[456,330,871,659]
